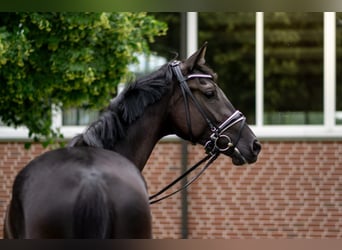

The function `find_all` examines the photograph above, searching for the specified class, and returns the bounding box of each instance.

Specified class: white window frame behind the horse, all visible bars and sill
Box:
[0,12,342,140]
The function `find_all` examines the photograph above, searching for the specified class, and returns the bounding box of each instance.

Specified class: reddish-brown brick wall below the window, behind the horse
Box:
[0,141,342,239]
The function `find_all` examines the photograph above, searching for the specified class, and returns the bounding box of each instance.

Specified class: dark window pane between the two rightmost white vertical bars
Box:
[264,12,323,124]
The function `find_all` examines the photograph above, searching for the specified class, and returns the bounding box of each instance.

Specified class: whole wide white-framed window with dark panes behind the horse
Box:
[0,12,342,140]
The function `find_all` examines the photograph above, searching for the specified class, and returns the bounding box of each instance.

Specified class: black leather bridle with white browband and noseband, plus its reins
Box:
[149,61,247,204]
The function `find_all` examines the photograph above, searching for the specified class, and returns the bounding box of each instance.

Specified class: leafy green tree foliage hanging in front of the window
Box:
[0,12,166,144]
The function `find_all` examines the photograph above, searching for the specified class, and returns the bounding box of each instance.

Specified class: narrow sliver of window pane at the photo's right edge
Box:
[336,13,342,125]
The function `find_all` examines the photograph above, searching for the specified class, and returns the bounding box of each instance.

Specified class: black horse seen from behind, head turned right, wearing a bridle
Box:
[4,44,261,238]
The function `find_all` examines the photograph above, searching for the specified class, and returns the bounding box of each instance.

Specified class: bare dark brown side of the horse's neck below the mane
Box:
[114,94,169,171]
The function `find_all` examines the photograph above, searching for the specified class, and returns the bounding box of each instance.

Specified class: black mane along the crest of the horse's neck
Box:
[68,64,172,149]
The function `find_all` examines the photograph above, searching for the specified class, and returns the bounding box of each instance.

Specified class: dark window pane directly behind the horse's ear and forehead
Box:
[198,12,255,124]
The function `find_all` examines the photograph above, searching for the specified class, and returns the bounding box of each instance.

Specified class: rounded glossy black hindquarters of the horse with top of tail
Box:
[8,147,151,238]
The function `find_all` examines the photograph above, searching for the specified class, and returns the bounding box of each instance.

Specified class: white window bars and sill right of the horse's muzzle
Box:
[251,12,342,140]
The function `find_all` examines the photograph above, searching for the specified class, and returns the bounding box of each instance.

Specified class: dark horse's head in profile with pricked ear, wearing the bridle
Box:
[170,43,261,165]
